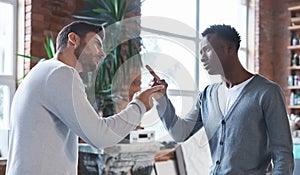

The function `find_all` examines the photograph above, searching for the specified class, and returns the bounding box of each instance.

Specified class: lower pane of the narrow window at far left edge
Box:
[0,85,10,129]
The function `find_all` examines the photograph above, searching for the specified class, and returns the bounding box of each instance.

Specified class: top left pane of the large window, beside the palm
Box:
[142,0,196,37]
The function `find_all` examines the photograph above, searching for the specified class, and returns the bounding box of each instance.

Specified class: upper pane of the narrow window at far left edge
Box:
[0,2,14,75]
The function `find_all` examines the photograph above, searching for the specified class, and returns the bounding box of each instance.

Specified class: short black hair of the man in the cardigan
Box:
[202,24,241,50]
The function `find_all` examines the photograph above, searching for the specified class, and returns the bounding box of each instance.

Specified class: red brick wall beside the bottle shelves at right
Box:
[255,0,300,105]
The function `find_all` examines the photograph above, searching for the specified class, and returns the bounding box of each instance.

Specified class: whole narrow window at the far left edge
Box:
[0,0,17,156]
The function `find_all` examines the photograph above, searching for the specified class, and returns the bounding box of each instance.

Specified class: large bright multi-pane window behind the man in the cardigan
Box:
[141,0,248,140]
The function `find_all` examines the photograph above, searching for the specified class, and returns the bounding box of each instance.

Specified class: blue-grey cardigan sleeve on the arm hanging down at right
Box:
[262,85,294,175]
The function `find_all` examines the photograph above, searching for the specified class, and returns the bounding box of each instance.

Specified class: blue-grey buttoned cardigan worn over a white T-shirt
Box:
[157,75,294,175]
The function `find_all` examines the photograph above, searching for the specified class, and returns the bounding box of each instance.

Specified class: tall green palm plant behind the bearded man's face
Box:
[74,0,142,116]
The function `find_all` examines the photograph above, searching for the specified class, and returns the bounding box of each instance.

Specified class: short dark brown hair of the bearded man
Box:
[56,21,104,51]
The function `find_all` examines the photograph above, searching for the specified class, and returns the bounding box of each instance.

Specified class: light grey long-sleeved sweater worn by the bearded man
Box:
[6,60,146,175]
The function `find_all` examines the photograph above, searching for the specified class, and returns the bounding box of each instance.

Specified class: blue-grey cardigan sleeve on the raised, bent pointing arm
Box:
[156,95,203,142]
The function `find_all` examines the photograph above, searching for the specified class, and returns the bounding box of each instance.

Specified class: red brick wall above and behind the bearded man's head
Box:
[24,0,83,72]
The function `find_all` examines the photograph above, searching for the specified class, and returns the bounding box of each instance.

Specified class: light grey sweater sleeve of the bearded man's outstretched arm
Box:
[44,67,146,147]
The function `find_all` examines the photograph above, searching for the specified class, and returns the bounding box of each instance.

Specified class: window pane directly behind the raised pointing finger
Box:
[142,37,197,91]
